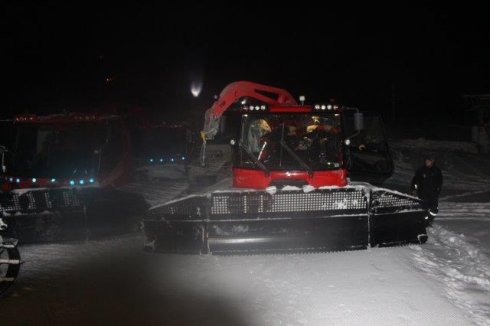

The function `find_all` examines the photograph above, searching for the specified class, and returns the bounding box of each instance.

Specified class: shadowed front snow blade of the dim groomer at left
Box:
[0,188,147,243]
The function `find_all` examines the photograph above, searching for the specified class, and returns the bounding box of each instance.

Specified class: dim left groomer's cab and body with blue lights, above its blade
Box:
[3,112,132,191]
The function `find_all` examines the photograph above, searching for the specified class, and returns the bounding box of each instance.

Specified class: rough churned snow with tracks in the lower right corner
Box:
[410,225,490,325]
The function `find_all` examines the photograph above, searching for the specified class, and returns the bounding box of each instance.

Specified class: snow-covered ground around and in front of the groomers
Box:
[0,141,490,326]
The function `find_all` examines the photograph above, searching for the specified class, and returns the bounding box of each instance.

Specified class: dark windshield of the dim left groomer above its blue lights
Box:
[12,123,106,178]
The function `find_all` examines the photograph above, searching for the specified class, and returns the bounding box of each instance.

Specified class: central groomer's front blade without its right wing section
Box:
[144,188,369,253]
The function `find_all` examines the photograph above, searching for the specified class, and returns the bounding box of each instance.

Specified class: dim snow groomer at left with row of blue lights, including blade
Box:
[0,113,142,243]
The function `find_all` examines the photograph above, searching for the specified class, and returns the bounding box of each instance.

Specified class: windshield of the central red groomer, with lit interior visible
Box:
[237,113,342,170]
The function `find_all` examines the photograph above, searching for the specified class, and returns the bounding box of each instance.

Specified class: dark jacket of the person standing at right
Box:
[412,164,442,200]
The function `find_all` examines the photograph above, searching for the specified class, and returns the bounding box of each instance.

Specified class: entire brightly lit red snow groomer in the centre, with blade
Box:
[144,82,427,254]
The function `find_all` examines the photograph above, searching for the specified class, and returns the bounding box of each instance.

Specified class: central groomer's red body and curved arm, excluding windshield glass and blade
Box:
[202,81,347,189]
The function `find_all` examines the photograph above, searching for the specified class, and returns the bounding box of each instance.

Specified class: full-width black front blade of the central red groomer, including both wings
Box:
[143,185,426,254]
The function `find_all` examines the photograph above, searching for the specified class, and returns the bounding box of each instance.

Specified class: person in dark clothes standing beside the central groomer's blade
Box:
[411,156,442,226]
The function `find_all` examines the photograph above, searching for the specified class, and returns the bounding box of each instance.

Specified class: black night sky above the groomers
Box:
[0,1,490,119]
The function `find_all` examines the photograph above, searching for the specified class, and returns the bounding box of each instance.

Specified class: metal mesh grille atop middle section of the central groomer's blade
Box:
[211,190,367,215]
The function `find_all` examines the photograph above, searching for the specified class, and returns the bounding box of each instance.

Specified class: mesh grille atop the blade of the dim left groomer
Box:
[0,189,81,214]
